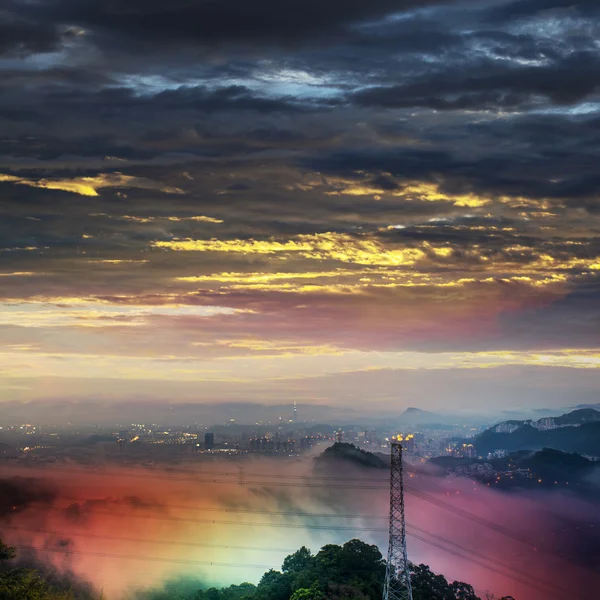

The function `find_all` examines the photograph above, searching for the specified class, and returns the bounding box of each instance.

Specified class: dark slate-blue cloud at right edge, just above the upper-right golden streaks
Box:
[302,118,599,204]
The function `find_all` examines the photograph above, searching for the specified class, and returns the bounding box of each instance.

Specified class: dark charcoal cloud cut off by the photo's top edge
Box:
[28,0,450,45]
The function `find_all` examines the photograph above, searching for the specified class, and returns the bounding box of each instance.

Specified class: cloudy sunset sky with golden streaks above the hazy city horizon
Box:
[0,0,600,412]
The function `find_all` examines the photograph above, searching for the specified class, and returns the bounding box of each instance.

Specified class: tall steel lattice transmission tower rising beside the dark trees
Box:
[383,436,413,600]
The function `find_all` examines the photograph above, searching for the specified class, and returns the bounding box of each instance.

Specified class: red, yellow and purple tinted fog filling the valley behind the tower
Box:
[0,458,600,600]
